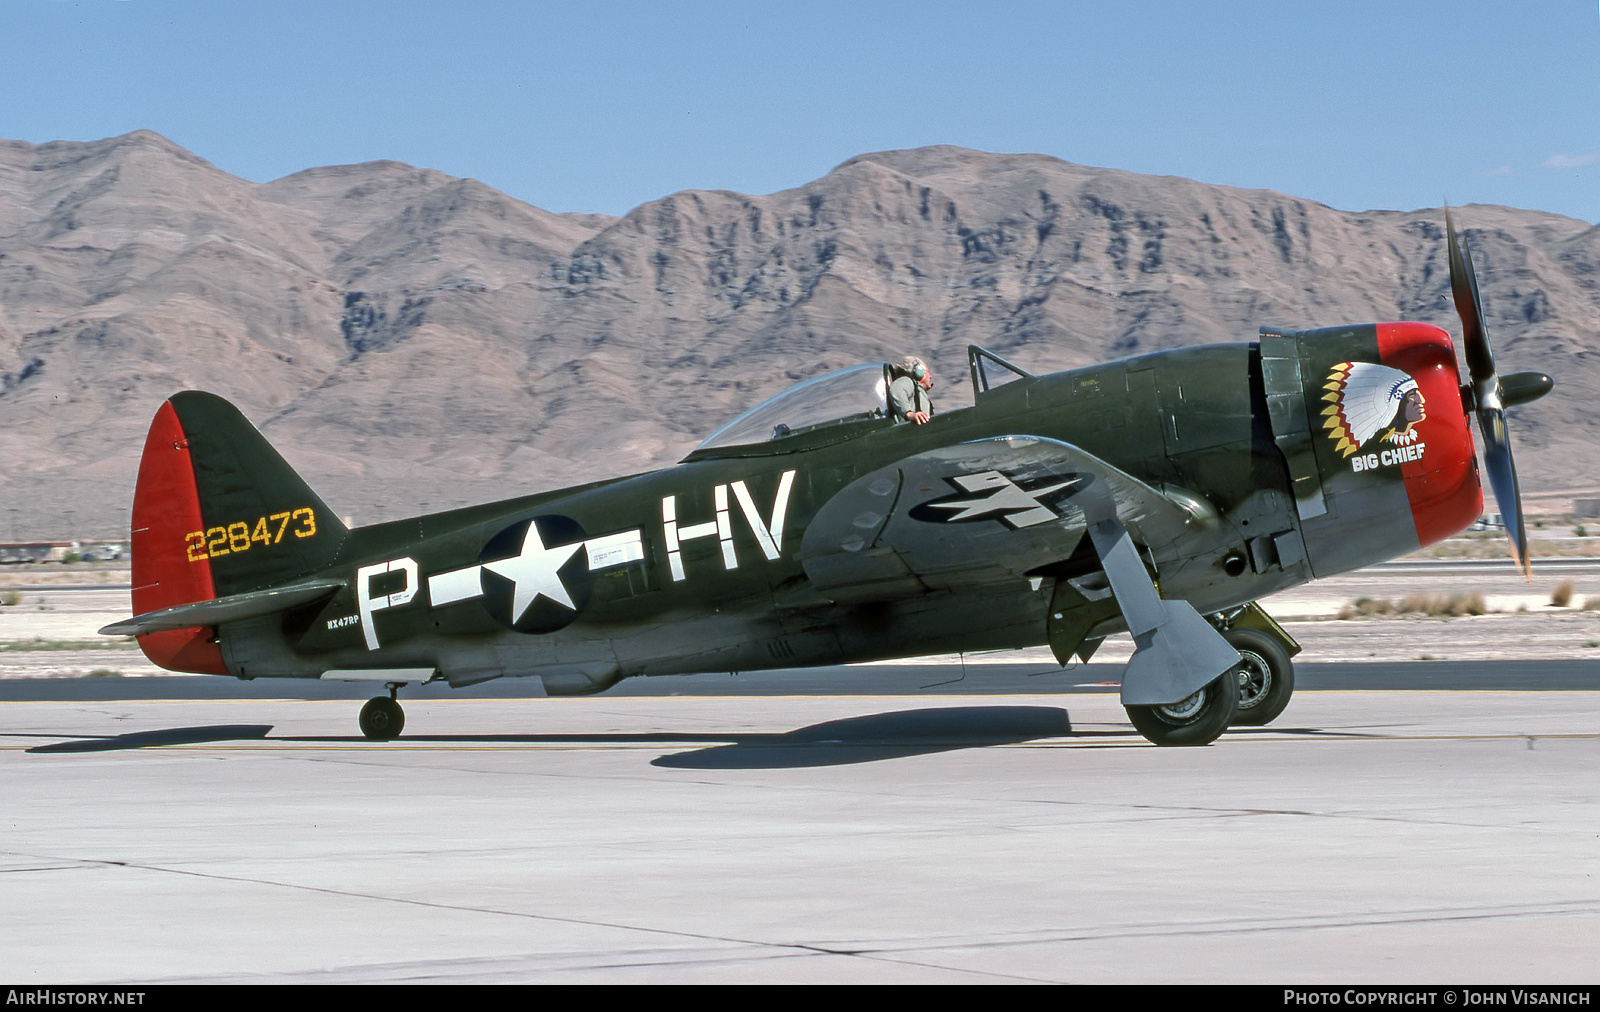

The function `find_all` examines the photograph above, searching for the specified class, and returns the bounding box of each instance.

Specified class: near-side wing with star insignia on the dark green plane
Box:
[800,436,1197,600]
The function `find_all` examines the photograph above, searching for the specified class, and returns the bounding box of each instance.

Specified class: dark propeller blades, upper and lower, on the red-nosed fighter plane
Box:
[1445,207,1542,583]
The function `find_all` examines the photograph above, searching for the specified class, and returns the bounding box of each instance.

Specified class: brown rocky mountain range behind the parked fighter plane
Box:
[0,131,1600,540]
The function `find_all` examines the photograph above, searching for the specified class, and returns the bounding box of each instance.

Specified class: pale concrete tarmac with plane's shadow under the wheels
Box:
[0,688,1600,985]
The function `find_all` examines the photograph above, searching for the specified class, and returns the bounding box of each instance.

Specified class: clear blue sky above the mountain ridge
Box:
[9,0,1600,221]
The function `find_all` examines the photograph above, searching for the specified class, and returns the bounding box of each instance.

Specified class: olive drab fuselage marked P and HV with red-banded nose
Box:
[162,325,1482,693]
